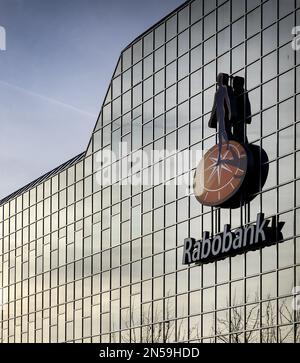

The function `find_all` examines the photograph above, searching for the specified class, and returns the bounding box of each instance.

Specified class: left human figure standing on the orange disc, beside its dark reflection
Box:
[209,73,231,165]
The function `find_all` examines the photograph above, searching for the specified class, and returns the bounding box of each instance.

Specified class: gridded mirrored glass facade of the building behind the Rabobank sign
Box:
[0,0,300,342]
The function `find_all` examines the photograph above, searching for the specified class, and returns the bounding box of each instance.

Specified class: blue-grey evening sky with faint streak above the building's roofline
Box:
[0,0,184,199]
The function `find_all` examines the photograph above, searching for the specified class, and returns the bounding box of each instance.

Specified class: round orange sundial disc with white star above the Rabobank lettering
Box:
[194,140,248,206]
